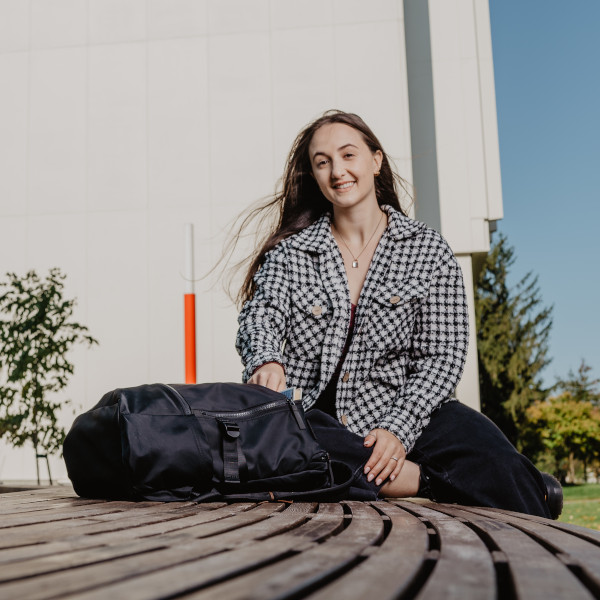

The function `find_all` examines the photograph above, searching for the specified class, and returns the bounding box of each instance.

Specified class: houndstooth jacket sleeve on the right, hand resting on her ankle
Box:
[379,247,469,453]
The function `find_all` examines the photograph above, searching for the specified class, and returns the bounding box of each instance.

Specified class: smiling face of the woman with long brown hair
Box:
[308,123,382,213]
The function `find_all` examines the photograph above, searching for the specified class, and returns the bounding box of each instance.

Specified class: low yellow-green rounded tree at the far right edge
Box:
[526,392,600,483]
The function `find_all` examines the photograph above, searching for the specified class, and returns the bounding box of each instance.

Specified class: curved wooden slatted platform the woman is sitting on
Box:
[0,488,600,600]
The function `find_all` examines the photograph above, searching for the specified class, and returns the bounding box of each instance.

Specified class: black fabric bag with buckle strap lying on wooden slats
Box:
[63,383,353,501]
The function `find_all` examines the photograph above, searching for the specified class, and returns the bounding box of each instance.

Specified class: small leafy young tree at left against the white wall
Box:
[0,268,98,482]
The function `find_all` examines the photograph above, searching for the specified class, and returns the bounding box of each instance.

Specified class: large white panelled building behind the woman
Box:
[0,0,502,480]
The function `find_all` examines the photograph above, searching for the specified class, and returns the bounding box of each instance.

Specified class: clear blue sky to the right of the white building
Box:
[490,0,600,384]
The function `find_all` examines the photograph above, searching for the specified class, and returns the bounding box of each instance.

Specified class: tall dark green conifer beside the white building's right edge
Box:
[475,235,552,451]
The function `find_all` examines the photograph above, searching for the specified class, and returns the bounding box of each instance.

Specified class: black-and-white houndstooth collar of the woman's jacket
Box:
[289,204,425,254]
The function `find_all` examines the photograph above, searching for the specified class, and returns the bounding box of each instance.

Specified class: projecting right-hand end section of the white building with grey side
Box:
[404,0,502,408]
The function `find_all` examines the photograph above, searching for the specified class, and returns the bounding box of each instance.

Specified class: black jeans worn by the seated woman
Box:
[307,401,550,518]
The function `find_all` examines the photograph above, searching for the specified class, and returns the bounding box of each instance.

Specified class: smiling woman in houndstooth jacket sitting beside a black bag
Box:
[236,111,551,517]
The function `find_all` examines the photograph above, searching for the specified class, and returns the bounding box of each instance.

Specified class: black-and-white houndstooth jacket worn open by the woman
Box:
[236,206,468,452]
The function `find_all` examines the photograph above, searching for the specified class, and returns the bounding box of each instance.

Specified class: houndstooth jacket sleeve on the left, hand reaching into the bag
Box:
[236,244,289,383]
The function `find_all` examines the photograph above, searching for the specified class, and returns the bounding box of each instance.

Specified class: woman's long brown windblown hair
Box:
[229,110,410,306]
